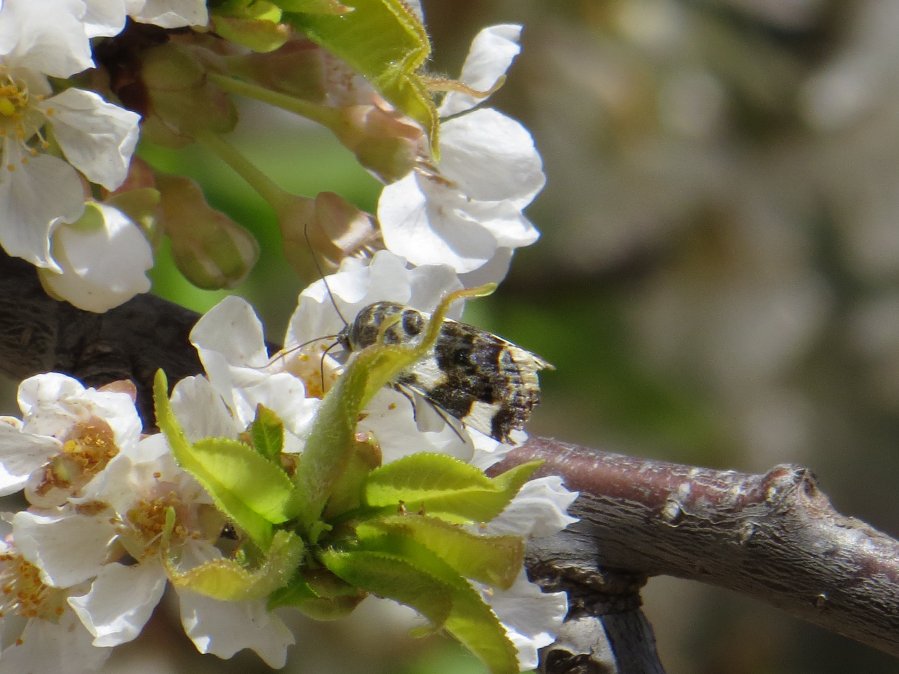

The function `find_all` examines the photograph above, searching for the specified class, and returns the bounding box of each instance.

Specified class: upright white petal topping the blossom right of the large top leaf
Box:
[438,24,521,117]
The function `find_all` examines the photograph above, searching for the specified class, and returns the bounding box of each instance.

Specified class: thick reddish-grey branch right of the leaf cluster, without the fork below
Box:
[495,438,899,656]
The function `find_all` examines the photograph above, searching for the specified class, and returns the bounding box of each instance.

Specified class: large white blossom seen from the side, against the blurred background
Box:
[378,25,545,282]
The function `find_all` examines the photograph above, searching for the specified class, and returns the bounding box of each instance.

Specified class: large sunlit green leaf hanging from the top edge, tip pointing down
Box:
[282,0,438,150]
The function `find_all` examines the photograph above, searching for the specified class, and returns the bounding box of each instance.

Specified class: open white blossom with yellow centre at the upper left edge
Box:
[0,15,139,272]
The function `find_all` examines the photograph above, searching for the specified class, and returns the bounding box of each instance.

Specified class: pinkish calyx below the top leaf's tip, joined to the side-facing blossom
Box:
[331,105,425,183]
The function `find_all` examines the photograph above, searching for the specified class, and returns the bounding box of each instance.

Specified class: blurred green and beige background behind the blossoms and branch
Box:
[74,0,899,674]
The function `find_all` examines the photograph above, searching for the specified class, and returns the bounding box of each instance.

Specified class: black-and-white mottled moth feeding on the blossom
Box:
[337,302,553,442]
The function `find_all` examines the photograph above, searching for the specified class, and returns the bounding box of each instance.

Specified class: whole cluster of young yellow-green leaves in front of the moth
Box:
[154,287,539,674]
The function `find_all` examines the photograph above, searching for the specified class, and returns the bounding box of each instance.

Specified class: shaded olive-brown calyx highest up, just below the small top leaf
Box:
[141,43,237,147]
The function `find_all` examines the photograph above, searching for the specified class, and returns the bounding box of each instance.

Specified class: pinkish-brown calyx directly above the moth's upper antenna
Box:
[278,192,384,276]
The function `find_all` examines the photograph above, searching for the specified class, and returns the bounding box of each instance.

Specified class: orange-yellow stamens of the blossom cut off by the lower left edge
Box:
[0,552,66,622]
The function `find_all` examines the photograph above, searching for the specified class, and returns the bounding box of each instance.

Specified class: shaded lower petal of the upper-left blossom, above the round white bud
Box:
[0,144,84,271]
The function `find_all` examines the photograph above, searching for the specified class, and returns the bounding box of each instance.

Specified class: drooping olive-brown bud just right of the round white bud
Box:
[157,175,259,290]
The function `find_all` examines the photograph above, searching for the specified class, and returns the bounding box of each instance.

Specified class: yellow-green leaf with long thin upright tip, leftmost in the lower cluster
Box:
[153,370,293,549]
